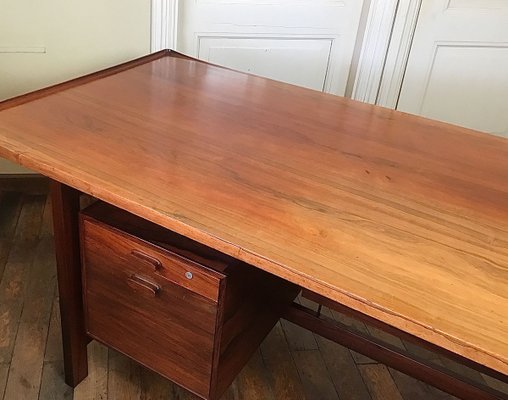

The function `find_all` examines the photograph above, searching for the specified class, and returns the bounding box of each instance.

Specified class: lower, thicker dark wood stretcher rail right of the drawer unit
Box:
[284,303,507,400]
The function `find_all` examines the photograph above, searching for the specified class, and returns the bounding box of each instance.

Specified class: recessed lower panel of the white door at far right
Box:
[420,43,508,134]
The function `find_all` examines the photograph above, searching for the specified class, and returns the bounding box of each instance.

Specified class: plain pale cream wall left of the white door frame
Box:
[0,0,150,174]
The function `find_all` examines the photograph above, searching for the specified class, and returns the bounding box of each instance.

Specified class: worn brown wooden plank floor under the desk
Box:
[0,181,508,400]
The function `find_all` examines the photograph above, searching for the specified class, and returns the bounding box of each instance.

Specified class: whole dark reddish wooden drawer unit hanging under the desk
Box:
[80,202,298,399]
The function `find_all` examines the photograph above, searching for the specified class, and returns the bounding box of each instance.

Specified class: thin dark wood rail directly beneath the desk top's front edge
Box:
[302,289,508,383]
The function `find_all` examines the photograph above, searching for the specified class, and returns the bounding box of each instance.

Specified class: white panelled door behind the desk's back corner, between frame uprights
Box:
[177,0,363,95]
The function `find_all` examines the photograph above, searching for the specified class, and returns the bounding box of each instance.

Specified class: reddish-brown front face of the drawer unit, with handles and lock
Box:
[81,218,223,397]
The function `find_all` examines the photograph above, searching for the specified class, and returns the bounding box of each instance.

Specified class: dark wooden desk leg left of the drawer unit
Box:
[51,181,89,387]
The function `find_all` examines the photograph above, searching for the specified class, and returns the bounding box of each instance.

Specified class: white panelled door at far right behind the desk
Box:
[397,0,508,136]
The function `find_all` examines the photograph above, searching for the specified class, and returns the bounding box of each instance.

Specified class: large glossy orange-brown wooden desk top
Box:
[0,51,508,374]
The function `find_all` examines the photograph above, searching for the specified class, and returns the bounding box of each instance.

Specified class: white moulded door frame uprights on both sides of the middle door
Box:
[150,0,422,108]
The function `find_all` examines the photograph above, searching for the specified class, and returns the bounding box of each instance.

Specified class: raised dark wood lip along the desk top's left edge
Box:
[0,50,171,111]
